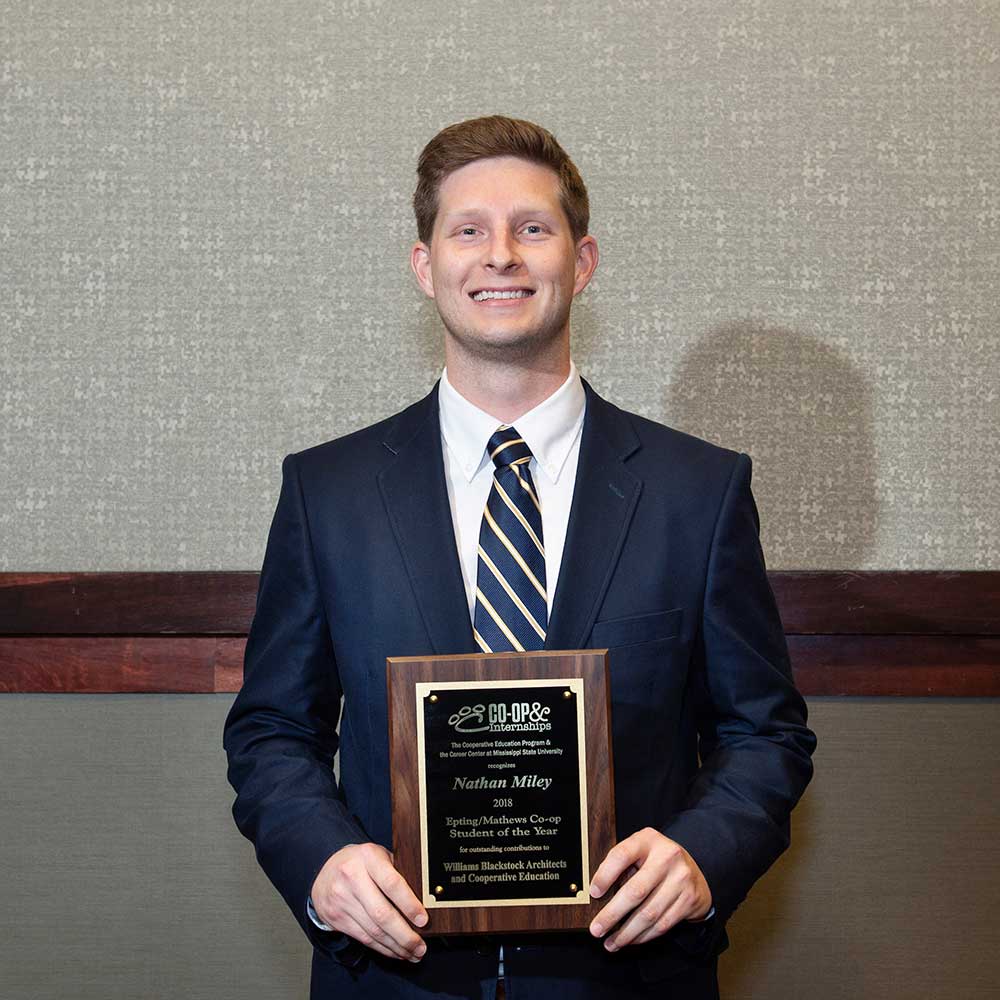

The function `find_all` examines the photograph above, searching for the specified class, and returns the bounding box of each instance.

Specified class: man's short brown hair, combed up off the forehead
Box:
[413,115,590,243]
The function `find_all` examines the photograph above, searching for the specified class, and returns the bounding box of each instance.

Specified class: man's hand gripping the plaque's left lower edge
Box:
[311,844,427,962]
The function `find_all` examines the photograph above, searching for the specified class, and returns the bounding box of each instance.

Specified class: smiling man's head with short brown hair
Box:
[410,117,598,372]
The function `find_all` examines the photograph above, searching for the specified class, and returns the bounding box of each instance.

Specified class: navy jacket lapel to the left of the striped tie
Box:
[378,386,476,655]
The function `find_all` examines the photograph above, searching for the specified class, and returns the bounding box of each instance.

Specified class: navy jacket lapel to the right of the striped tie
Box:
[545,381,642,649]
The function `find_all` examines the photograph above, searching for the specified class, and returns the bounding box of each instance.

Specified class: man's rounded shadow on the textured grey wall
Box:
[665,320,878,569]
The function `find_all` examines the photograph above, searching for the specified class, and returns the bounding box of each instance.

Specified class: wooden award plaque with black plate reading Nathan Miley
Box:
[386,650,615,934]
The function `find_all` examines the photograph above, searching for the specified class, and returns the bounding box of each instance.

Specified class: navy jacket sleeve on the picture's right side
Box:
[663,455,816,936]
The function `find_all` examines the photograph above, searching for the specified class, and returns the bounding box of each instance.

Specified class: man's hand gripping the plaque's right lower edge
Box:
[590,827,712,951]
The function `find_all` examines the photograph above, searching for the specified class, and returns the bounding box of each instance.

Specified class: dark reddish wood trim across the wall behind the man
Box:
[0,571,1000,697]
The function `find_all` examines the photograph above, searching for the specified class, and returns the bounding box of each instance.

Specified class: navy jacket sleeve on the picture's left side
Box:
[223,455,370,960]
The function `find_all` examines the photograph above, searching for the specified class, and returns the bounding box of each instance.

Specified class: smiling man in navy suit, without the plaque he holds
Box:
[225,116,815,998]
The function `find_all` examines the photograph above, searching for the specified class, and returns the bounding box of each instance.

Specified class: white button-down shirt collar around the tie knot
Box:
[438,361,587,483]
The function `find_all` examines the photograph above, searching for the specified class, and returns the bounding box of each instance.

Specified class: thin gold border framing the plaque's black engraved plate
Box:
[414,677,590,909]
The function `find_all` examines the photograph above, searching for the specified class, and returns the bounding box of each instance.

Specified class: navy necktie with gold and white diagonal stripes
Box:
[473,425,548,653]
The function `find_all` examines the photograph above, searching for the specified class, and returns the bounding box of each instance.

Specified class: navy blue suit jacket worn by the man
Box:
[225,383,815,996]
